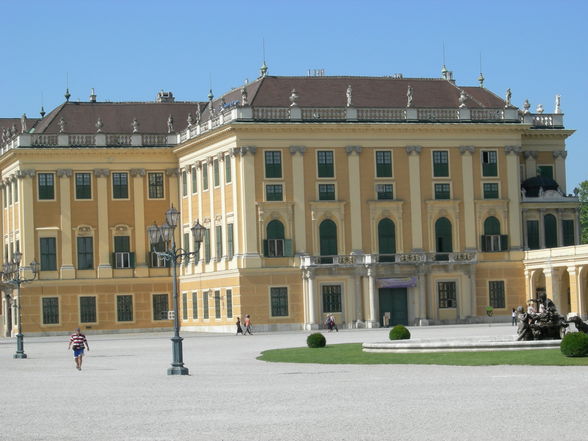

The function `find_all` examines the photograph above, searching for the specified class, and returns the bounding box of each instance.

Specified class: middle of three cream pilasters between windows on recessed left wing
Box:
[94,168,112,279]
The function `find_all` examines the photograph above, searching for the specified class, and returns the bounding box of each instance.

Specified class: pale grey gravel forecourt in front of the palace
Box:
[0,325,588,441]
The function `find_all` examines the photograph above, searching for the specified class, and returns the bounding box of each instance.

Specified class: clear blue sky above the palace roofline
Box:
[0,0,588,188]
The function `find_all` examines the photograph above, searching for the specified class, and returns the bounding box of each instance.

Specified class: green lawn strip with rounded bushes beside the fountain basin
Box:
[257,343,588,366]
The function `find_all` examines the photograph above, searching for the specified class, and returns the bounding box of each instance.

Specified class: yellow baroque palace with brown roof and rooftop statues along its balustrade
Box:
[0,66,586,335]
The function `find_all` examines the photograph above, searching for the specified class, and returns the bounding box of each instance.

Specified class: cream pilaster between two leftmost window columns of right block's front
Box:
[290,145,307,255]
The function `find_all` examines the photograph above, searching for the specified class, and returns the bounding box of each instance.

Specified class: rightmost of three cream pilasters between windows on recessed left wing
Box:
[130,168,149,277]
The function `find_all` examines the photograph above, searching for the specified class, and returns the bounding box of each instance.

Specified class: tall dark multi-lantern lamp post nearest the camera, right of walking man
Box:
[147,206,206,375]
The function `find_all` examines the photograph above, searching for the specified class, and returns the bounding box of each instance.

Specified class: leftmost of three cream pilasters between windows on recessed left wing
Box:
[57,168,76,279]
